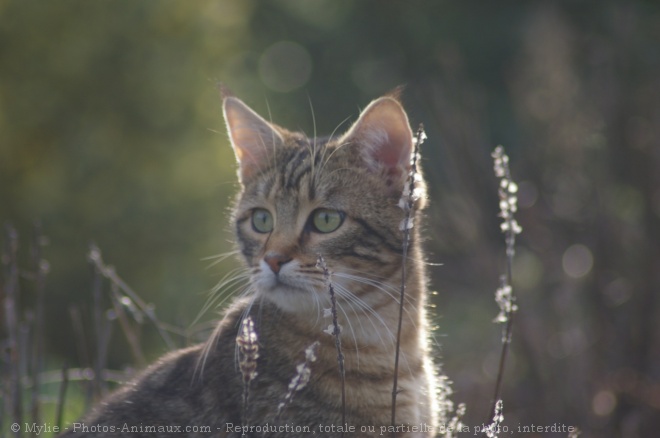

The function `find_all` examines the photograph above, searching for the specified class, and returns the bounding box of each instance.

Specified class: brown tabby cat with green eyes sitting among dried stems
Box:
[64,91,438,437]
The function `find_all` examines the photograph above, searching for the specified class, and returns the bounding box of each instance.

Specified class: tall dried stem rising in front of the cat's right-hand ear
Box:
[392,124,426,438]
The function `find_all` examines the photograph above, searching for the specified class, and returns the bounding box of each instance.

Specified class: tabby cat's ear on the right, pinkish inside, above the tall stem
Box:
[342,96,413,193]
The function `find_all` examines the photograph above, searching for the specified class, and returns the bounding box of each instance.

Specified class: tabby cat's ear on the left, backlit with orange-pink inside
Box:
[222,96,283,183]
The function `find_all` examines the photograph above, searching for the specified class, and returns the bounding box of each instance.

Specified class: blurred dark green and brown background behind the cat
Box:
[0,0,660,437]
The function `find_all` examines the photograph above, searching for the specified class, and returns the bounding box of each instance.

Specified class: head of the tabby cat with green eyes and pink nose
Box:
[224,92,424,312]
